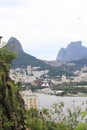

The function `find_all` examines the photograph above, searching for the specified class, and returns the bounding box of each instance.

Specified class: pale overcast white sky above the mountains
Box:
[0,0,87,60]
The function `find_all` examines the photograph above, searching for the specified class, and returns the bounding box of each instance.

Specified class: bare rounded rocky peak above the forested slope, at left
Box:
[7,37,23,54]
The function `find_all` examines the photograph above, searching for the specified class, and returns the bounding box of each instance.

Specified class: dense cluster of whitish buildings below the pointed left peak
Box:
[10,66,49,85]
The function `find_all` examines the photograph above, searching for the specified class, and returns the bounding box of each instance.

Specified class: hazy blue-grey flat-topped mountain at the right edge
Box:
[57,41,87,62]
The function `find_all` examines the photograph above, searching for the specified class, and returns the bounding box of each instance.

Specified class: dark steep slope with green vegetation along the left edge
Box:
[0,47,25,130]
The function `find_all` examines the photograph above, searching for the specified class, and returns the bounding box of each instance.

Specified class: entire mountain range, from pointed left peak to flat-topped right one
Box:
[7,37,87,76]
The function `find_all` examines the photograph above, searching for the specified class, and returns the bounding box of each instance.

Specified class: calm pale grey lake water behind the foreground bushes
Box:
[37,94,87,109]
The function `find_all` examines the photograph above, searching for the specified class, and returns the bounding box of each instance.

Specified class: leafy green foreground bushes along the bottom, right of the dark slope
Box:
[26,101,87,130]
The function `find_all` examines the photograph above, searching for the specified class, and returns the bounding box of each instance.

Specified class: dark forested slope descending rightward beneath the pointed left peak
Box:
[11,52,52,70]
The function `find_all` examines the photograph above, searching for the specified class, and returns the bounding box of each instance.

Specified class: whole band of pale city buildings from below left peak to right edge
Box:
[10,66,87,87]
